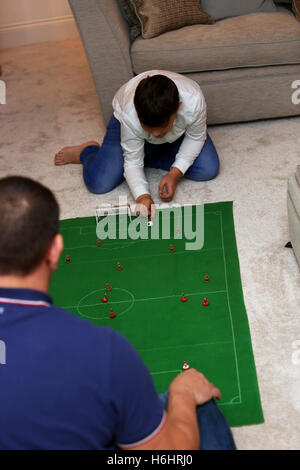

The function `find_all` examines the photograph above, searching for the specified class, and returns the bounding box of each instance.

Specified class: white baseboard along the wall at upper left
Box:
[0,15,78,49]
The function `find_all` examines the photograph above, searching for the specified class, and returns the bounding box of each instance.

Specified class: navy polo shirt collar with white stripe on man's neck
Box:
[0,287,53,307]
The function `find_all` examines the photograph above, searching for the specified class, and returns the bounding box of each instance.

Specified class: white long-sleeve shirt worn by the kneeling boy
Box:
[112,70,207,199]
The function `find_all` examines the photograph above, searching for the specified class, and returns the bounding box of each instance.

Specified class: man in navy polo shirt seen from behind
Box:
[0,177,234,449]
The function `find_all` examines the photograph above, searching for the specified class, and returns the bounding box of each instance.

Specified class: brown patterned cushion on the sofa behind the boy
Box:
[131,0,214,39]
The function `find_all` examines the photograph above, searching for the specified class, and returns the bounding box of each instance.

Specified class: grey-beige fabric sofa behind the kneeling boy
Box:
[69,0,300,124]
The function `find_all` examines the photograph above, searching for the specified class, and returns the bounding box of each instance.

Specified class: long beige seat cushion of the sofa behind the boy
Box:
[131,9,300,74]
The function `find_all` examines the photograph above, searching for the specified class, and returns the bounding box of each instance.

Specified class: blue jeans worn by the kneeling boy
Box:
[80,116,220,194]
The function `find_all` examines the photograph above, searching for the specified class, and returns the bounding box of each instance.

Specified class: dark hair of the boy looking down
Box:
[134,75,179,127]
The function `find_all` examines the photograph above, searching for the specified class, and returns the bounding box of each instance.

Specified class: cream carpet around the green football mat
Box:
[0,39,300,449]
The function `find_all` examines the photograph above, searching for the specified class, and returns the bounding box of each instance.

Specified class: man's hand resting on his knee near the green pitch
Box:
[169,369,221,405]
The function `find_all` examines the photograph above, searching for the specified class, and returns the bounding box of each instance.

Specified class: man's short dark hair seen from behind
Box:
[0,176,59,276]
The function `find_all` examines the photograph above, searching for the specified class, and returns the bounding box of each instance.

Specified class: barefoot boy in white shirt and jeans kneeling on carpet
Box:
[55,70,219,215]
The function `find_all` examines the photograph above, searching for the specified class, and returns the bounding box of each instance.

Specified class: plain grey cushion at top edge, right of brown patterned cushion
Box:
[202,0,276,20]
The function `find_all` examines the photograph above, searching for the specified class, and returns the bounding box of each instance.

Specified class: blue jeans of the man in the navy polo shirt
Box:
[159,392,236,450]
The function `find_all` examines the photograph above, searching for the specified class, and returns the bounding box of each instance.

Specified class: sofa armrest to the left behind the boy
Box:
[69,0,133,124]
